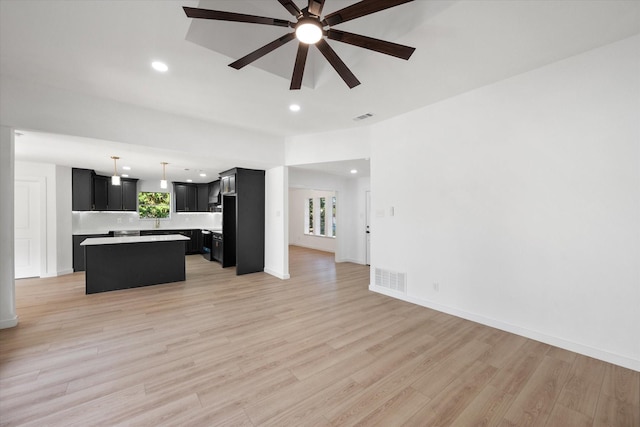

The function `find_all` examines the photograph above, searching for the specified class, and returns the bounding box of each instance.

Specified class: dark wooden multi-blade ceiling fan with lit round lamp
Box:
[183,0,415,90]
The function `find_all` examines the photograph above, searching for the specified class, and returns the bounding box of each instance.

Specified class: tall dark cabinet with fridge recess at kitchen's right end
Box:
[220,168,265,275]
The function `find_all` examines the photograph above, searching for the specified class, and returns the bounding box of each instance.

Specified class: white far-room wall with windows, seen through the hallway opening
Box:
[289,188,339,253]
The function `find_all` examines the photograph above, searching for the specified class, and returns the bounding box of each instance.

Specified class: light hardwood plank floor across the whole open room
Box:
[0,247,640,427]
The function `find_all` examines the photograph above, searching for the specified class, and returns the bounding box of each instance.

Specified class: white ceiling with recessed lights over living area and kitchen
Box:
[0,0,640,181]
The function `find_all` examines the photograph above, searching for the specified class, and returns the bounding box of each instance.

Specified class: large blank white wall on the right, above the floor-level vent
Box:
[371,36,640,370]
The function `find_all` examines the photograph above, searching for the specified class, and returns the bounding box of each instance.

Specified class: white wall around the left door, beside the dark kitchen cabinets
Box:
[15,162,73,277]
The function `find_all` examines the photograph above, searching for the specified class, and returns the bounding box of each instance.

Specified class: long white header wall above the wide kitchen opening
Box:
[0,75,284,169]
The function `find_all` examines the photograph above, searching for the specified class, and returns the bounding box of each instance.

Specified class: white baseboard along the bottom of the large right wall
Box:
[369,284,640,371]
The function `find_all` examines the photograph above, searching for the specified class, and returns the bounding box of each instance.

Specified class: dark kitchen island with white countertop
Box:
[80,234,189,294]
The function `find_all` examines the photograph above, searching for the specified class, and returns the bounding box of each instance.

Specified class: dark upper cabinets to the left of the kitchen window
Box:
[71,168,138,212]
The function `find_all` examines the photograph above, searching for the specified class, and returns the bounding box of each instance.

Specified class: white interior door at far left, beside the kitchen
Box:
[14,180,41,279]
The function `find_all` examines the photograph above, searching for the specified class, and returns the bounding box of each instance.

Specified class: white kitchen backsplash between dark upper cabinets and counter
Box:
[71,212,222,234]
